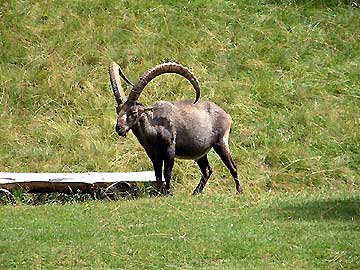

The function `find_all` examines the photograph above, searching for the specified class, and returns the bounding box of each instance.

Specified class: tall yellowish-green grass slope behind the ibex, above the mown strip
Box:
[0,0,360,193]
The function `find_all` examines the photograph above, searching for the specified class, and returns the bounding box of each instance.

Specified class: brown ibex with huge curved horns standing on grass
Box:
[109,63,242,195]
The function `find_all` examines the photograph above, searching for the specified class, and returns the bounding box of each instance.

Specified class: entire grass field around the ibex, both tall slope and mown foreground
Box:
[0,0,360,269]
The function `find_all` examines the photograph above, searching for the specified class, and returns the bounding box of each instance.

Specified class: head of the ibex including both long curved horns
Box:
[109,63,200,137]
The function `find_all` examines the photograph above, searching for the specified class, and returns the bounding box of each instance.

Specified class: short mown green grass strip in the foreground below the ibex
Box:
[0,192,360,269]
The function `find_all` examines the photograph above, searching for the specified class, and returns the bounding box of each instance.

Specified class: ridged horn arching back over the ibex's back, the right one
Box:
[128,62,200,103]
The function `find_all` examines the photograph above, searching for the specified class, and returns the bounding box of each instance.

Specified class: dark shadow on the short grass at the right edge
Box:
[276,197,360,221]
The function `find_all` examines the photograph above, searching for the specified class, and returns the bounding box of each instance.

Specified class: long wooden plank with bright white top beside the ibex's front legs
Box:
[0,171,156,192]
